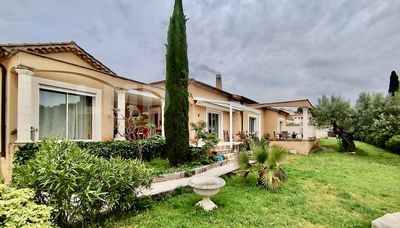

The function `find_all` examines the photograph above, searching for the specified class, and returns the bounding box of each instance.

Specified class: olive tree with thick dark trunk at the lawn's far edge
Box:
[312,95,357,152]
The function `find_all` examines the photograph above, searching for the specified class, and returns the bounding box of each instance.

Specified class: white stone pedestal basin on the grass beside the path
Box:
[189,176,226,211]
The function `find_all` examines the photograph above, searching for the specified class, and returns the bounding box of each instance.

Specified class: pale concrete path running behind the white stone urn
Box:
[138,161,239,196]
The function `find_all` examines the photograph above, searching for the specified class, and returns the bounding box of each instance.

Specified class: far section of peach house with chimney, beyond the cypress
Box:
[150,74,294,145]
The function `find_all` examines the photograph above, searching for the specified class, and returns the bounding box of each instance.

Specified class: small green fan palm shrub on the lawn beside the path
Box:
[239,140,287,190]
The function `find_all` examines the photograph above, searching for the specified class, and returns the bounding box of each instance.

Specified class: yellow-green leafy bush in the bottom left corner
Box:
[0,184,51,227]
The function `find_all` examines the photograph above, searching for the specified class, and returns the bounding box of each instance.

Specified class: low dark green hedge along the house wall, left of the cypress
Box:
[14,137,166,165]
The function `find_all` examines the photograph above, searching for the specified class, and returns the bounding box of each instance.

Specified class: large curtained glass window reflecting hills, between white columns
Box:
[39,89,93,140]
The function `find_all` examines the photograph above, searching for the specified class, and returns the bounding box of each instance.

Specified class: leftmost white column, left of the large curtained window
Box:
[15,68,33,143]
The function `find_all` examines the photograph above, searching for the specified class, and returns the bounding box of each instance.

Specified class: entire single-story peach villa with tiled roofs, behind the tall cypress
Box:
[0,42,312,179]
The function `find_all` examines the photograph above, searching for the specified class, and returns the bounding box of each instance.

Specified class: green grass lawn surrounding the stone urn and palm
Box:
[102,140,400,227]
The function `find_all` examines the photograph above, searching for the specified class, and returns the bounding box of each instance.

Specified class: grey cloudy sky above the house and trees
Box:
[0,0,400,102]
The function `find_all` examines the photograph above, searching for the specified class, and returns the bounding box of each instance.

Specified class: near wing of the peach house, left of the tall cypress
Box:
[0,42,165,179]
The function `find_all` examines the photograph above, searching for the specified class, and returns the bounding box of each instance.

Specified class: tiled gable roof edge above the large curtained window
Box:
[0,41,116,75]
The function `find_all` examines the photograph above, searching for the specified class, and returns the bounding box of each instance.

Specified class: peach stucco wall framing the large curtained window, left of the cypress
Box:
[0,52,164,182]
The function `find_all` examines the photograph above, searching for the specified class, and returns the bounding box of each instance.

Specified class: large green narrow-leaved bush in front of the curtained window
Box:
[13,139,152,225]
